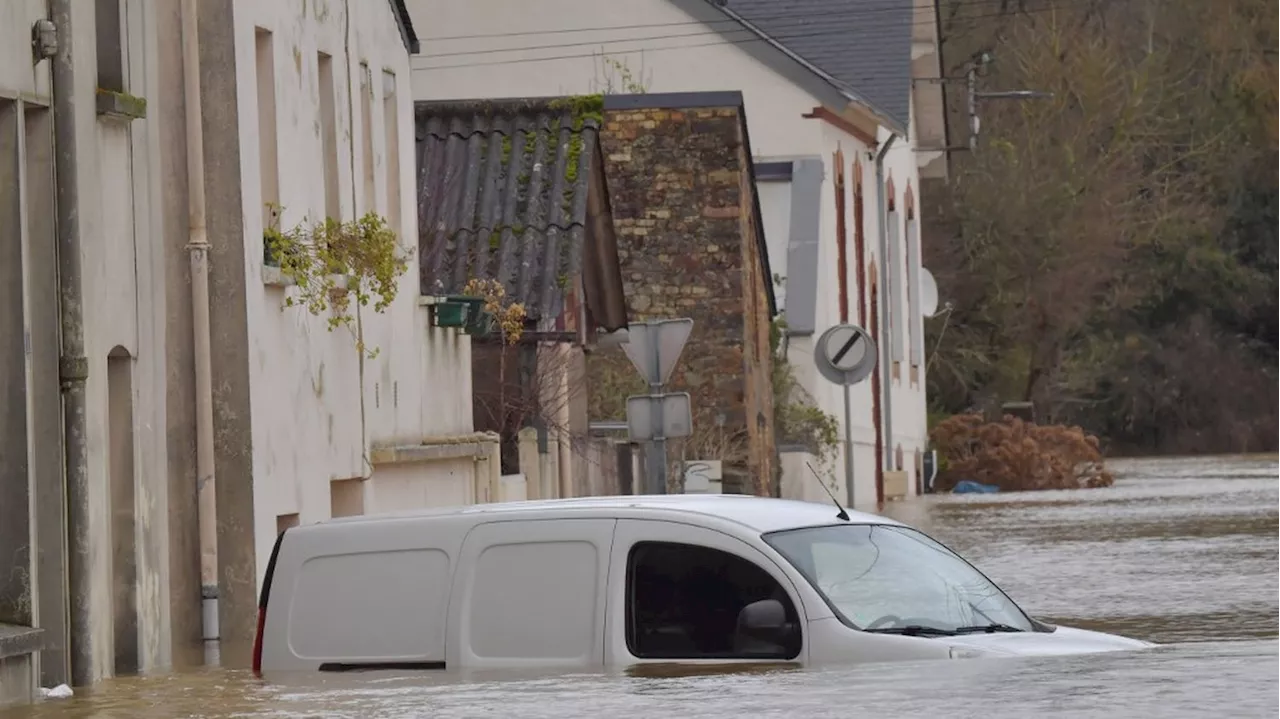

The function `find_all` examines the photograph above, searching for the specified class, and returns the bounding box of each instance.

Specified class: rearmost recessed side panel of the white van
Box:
[288,549,449,661]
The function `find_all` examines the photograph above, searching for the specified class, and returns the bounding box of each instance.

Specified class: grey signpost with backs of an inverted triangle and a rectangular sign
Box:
[622,319,694,494]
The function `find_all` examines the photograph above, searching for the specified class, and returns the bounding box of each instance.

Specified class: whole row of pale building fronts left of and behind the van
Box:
[0,0,499,702]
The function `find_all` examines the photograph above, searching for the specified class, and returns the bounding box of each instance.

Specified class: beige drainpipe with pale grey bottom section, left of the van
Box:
[182,0,218,652]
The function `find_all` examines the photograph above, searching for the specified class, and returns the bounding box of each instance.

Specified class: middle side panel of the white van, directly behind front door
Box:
[448,519,617,668]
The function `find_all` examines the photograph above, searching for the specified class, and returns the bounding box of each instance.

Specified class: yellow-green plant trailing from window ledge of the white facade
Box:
[262,204,410,356]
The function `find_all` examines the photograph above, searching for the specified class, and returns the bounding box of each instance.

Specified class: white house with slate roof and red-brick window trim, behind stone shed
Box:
[406,0,945,507]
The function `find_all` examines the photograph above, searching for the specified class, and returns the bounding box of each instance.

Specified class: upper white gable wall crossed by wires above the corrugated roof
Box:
[406,0,820,155]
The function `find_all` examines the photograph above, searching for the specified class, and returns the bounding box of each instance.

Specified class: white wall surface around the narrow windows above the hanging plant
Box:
[236,0,474,578]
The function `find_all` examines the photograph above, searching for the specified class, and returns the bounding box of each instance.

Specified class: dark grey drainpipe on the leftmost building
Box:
[49,0,93,687]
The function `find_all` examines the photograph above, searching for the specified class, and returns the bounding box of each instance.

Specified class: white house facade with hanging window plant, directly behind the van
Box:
[212,0,498,654]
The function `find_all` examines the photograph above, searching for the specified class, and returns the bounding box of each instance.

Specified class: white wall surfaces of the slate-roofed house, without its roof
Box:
[407,0,925,508]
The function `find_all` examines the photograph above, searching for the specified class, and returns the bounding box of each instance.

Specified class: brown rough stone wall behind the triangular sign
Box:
[589,102,774,494]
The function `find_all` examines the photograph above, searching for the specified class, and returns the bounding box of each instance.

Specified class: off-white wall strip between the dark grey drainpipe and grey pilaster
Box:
[73,0,170,676]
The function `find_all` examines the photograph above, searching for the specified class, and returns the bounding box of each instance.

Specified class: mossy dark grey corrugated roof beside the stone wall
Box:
[415,99,626,330]
